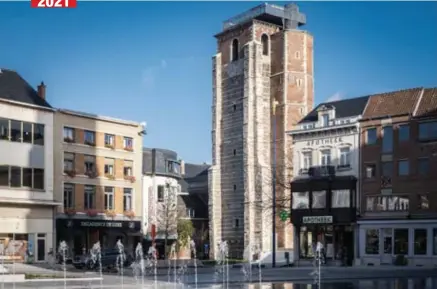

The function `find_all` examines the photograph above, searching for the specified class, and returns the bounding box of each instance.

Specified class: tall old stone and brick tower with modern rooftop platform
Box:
[209,4,314,258]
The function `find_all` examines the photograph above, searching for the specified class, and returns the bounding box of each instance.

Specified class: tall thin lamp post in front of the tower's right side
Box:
[272,100,278,268]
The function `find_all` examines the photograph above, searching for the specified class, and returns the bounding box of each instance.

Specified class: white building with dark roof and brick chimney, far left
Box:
[0,70,60,262]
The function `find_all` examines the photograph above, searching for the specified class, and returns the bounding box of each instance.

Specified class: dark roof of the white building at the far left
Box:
[0,68,52,108]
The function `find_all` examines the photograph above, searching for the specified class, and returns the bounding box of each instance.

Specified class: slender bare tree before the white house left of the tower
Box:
[156,179,179,257]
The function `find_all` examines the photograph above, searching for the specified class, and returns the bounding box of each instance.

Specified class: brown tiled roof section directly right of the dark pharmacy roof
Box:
[362,87,423,120]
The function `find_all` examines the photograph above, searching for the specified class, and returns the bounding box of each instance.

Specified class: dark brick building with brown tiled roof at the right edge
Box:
[356,88,437,266]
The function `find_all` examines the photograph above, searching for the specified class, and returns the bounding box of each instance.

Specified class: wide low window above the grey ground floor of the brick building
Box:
[366,195,410,212]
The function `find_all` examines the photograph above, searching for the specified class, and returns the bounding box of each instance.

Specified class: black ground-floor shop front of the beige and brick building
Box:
[56,218,142,256]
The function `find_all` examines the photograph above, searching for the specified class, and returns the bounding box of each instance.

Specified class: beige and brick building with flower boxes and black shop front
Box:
[54,110,145,254]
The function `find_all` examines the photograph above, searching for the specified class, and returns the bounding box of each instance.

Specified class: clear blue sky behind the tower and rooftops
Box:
[0,2,437,162]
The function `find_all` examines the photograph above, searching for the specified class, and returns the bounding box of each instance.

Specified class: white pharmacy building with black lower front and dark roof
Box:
[289,97,368,264]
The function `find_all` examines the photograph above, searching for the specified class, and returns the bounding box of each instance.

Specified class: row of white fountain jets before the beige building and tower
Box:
[58,240,270,288]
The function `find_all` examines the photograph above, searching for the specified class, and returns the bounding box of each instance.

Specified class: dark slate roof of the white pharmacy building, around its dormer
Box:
[299,96,369,123]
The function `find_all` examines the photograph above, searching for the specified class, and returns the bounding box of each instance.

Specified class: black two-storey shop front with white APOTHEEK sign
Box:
[291,176,357,266]
